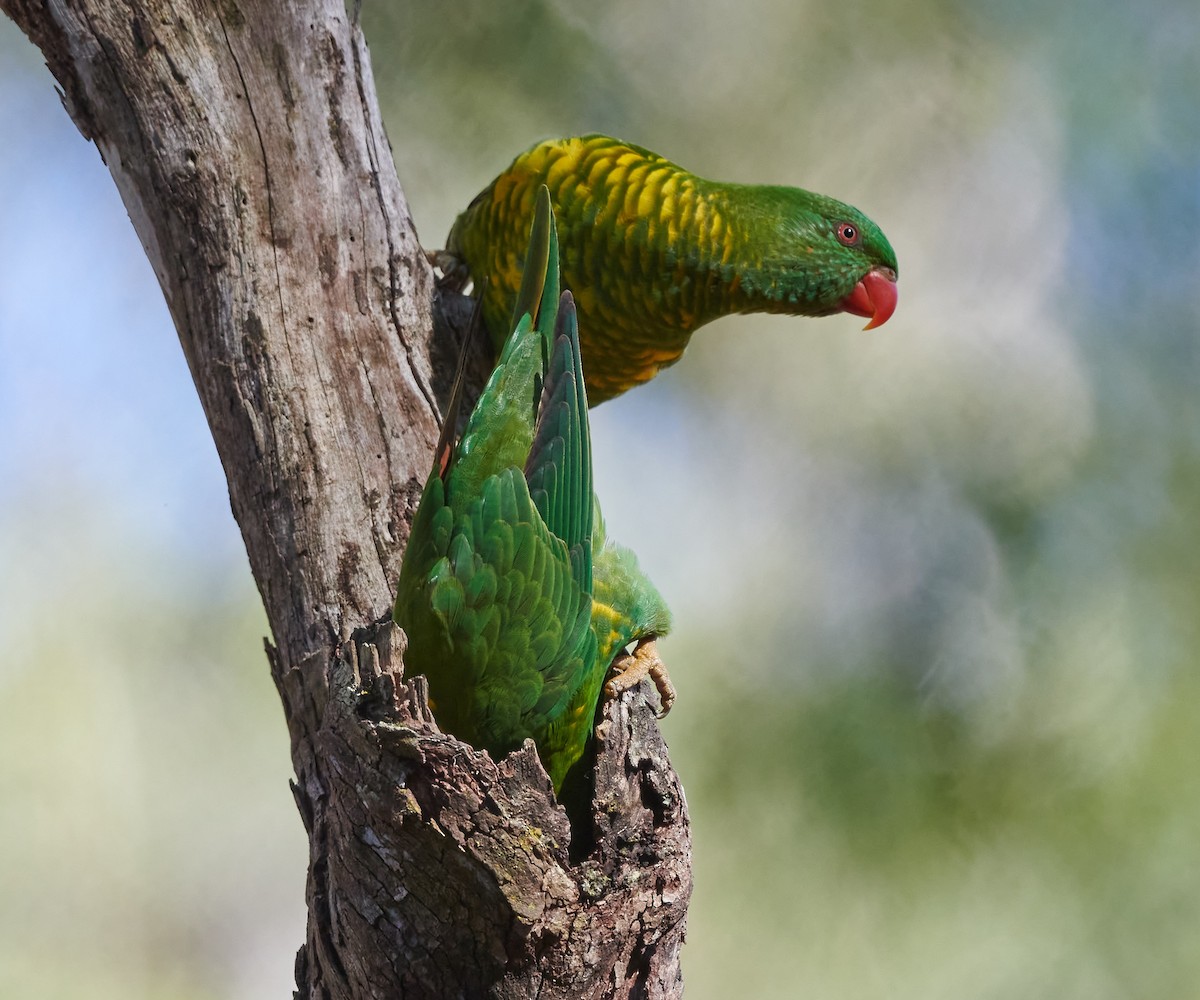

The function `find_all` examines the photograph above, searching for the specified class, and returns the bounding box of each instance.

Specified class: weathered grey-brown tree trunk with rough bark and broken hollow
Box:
[0,0,691,998]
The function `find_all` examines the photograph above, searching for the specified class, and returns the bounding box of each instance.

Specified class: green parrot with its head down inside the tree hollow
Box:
[394,187,674,794]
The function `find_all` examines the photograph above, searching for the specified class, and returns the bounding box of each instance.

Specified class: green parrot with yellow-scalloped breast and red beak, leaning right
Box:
[446,136,896,406]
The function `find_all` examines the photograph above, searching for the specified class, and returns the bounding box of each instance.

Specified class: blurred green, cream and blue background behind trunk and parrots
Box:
[0,0,1200,1000]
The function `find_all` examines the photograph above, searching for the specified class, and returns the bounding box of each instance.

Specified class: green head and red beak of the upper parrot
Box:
[731,186,896,329]
